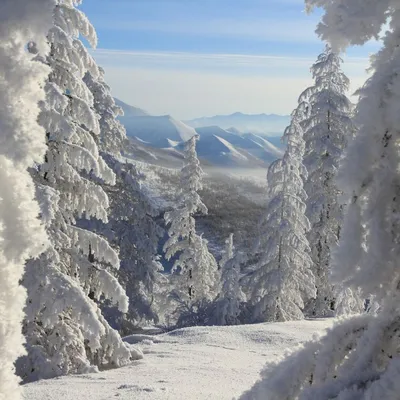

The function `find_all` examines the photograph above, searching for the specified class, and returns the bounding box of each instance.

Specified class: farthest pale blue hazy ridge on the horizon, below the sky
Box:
[184,112,290,136]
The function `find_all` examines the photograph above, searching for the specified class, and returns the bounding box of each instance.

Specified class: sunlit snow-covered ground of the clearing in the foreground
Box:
[25,320,332,400]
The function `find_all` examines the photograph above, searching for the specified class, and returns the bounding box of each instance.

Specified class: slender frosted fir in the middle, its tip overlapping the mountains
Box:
[164,136,219,304]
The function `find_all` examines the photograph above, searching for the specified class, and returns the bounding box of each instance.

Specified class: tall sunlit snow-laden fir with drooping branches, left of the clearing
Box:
[18,0,140,380]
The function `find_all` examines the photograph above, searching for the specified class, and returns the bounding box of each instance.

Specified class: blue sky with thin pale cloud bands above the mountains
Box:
[81,0,378,119]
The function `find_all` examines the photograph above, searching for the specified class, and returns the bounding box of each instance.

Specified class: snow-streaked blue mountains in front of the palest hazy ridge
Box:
[117,100,283,168]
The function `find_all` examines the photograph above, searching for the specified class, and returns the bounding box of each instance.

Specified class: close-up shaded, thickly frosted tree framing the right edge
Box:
[242,0,400,400]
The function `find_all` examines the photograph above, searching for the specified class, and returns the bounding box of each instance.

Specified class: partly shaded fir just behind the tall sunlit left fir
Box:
[84,68,164,334]
